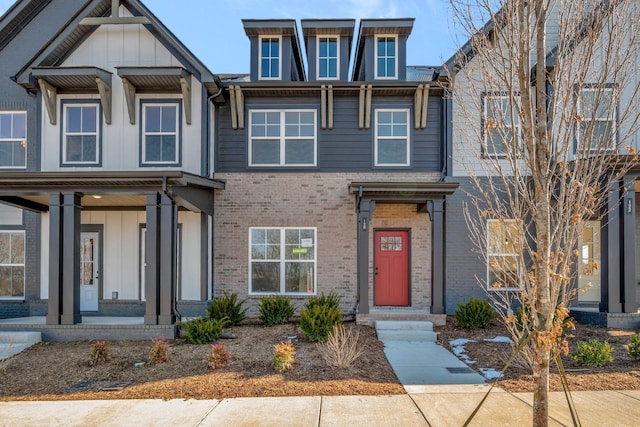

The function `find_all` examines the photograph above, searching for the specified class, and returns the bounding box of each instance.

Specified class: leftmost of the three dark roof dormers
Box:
[242,19,306,82]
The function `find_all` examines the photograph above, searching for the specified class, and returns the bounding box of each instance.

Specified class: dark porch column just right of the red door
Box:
[430,200,444,314]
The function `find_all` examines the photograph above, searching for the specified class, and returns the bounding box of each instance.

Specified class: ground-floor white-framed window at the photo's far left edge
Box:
[0,231,24,299]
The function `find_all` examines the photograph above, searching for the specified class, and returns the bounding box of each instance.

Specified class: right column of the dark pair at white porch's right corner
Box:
[158,194,178,325]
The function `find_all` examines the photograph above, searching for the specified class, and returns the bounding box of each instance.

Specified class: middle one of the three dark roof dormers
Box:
[300,19,356,81]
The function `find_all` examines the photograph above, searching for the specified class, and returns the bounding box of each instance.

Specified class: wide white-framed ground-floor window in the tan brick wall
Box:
[249,228,316,294]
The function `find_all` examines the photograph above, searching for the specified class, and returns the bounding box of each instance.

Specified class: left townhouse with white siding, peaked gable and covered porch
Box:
[0,0,224,335]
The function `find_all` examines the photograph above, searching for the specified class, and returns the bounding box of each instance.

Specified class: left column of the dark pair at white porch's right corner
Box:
[144,193,160,325]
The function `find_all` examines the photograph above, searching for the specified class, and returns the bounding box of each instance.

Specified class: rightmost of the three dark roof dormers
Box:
[353,18,414,81]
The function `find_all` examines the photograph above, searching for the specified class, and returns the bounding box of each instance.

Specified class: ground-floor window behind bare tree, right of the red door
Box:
[487,219,520,290]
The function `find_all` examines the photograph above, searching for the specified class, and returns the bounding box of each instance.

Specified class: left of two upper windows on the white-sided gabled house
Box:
[62,102,100,166]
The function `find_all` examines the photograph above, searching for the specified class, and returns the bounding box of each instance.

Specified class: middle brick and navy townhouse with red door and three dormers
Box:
[214,19,457,321]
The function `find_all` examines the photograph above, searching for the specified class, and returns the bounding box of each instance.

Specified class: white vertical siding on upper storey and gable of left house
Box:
[41,7,205,175]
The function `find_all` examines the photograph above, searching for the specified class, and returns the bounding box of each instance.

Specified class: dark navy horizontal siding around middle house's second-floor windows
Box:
[216,92,444,172]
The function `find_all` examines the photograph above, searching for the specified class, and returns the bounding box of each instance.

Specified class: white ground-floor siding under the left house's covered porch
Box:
[40,211,200,300]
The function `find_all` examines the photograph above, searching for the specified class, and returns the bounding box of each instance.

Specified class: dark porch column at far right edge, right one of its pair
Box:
[620,176,638,313]
